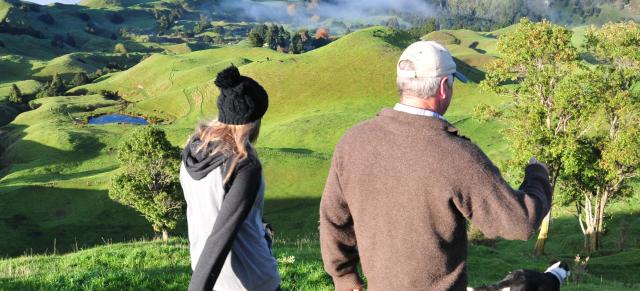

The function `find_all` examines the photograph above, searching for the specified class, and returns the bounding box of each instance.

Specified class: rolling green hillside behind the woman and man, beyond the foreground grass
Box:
[0,27,504,254]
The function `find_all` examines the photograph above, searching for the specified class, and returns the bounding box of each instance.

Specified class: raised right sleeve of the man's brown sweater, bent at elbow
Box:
[454,142,552,240]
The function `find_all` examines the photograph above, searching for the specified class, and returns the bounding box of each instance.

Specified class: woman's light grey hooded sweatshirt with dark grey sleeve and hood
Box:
[180,138,280,291]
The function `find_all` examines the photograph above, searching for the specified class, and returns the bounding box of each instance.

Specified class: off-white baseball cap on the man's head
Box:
[397,41,468,83]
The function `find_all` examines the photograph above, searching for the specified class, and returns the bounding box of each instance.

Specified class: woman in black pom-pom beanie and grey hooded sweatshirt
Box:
[180,66,280,291]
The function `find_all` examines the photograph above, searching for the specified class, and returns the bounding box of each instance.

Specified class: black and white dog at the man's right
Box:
[467,261,571,291]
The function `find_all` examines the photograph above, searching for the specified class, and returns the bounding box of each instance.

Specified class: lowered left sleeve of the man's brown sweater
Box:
[320,153,363,290]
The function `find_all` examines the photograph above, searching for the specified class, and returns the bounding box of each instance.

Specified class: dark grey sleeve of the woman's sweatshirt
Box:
[189,161,262,291]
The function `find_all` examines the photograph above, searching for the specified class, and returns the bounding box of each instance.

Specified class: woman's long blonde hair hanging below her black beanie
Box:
[194,120,260,183]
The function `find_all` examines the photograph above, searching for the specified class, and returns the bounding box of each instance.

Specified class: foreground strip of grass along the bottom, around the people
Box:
[0,216,640,290]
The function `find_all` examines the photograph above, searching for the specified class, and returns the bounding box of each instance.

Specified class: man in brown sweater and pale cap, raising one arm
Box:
[320,42,551,290]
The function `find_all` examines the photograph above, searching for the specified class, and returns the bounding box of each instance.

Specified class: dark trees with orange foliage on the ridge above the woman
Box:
[248,24,332,54]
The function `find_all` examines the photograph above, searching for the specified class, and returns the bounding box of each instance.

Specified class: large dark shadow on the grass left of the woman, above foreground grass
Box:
[0,186,186,257]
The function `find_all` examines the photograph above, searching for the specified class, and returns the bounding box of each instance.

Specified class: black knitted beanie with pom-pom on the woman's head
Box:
[215,65,269,125]
